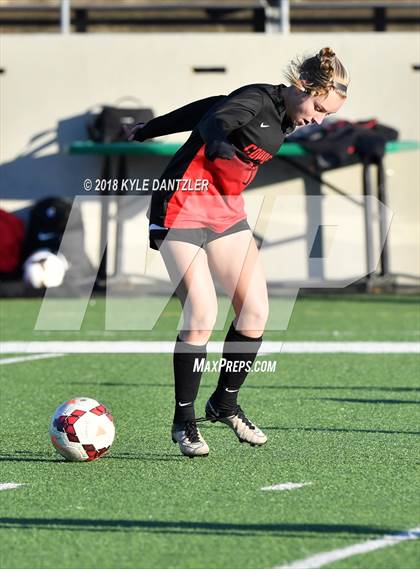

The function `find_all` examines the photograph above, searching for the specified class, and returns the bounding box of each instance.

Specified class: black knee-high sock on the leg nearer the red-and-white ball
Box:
[173,335,207,423]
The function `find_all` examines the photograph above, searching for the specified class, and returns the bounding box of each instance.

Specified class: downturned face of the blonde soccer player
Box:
[285,87,345,126]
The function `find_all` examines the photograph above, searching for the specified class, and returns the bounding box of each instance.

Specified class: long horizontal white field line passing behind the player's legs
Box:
[0,341,420,354]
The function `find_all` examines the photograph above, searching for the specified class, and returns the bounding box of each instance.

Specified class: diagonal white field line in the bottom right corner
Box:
[274,527,420,569]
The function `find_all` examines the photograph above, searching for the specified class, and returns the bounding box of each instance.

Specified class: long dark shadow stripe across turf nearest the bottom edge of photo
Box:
[0,518,406,538]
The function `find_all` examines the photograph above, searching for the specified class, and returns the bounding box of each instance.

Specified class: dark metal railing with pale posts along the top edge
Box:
[0,0,420,34]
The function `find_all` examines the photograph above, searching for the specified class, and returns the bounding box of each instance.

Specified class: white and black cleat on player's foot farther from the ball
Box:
[206,400,267,446]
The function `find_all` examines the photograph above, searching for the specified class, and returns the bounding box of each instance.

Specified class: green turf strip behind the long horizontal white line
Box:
[0,295,420,342]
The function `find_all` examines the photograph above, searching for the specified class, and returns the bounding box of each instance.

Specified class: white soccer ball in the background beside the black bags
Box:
[23,249,68,288]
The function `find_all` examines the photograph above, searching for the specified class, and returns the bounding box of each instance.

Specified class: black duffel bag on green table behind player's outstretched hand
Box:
[87,97,154,142]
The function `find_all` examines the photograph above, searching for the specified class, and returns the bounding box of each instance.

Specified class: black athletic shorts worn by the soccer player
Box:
[149,219,251,250]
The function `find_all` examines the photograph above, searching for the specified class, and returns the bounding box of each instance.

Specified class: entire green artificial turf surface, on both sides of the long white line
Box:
[0,297,420,569]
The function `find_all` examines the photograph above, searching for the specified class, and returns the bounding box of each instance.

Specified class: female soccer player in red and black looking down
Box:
[129,47,349,457]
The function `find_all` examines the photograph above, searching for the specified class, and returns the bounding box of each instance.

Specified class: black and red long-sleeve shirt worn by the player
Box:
[136,83,294,232]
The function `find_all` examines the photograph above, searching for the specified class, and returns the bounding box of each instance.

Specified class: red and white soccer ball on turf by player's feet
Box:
[50,397,115,461]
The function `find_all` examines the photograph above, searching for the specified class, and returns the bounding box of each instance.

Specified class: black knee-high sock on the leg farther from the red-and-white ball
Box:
[211,322,262,410]
